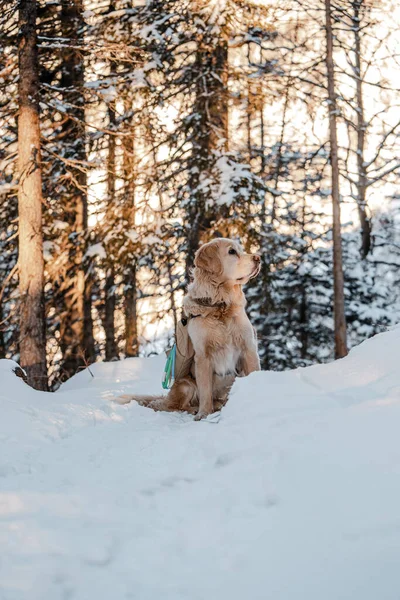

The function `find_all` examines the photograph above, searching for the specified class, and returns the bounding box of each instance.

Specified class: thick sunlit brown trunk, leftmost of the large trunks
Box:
[18,0,47,390]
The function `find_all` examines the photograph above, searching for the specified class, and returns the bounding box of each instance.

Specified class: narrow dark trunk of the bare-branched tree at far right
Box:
[352,0,371,259]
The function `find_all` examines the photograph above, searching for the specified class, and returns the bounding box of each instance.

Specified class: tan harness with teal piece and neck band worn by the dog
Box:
[162,298,227,390]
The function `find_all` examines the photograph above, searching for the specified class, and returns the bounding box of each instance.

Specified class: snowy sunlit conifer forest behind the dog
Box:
[0,0,400,390]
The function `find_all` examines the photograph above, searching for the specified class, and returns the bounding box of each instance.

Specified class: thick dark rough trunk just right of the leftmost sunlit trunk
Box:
[61,0,95,377]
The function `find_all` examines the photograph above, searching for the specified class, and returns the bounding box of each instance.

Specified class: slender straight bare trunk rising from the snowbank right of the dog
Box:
[325,0,347,358]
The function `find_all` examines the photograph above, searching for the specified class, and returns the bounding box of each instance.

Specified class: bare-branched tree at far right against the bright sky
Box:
[334,0,400,259]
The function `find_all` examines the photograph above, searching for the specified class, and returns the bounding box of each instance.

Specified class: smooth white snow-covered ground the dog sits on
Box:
[0,328,400,600]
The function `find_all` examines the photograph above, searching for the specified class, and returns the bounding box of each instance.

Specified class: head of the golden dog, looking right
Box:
[194,238,261,285]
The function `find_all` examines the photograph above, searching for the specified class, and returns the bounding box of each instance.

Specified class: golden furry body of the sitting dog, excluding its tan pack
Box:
[116,239,260,420]
